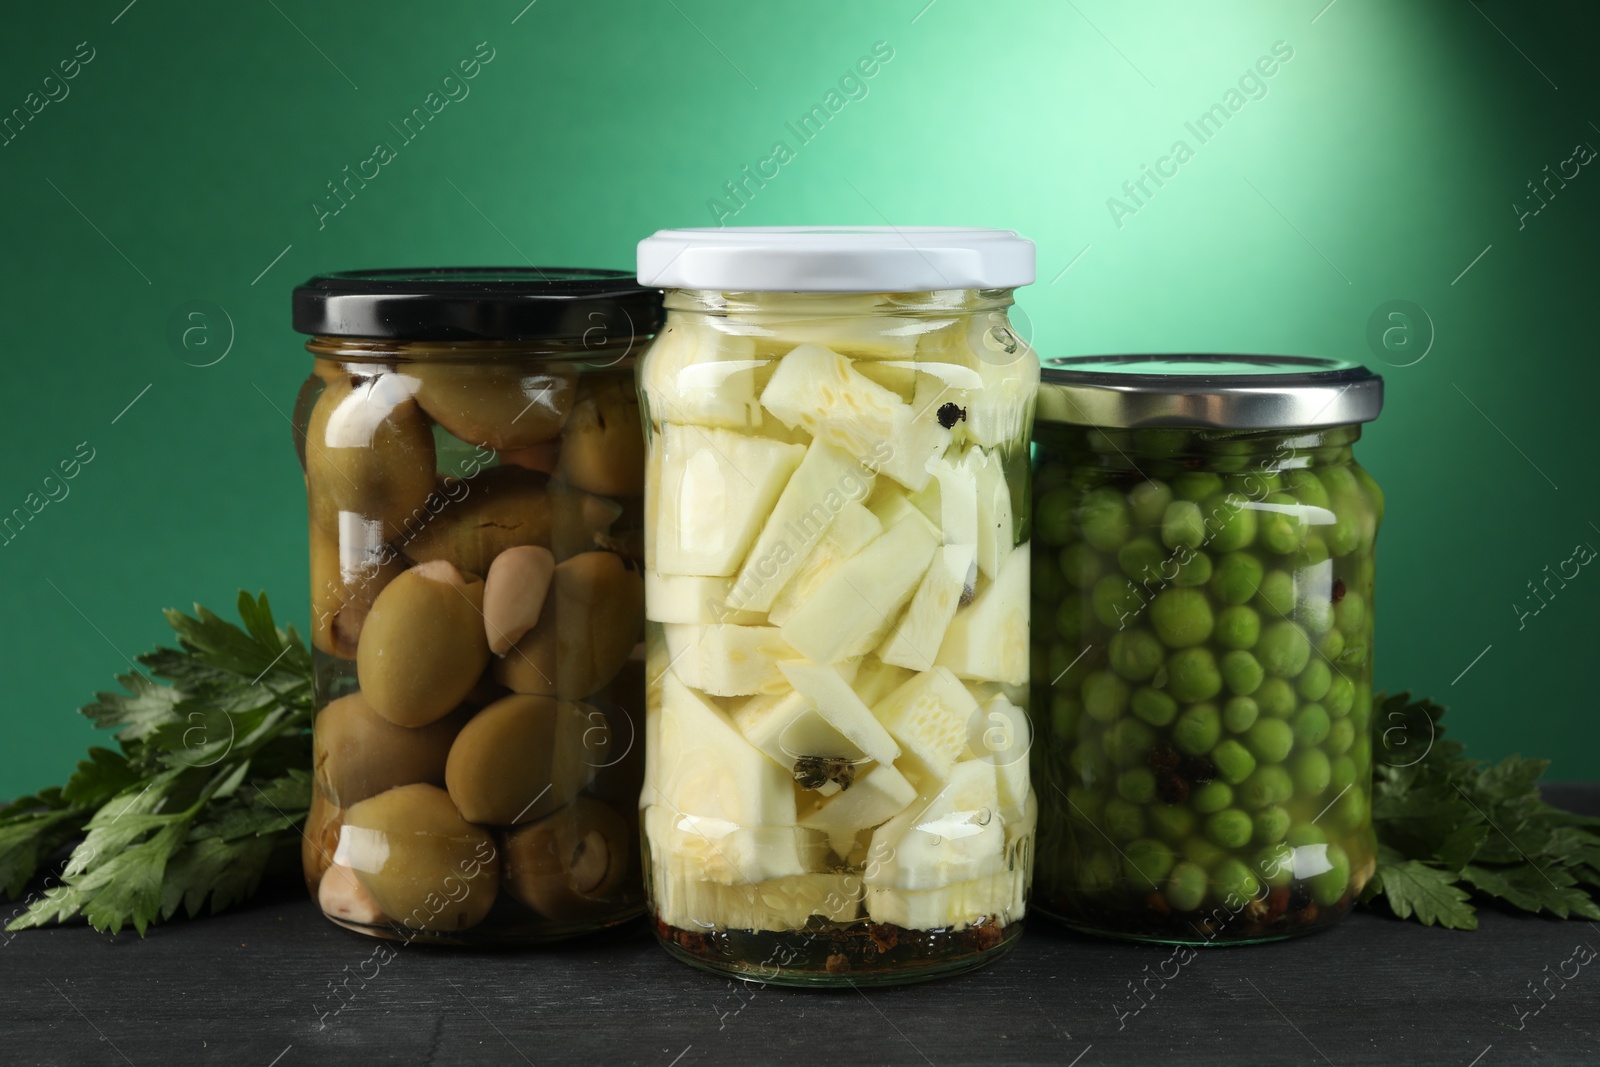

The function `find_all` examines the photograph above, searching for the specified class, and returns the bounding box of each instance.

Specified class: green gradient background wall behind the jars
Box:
[0,0,1600,795]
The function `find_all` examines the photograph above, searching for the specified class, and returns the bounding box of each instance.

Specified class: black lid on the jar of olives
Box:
[294,267,661,344]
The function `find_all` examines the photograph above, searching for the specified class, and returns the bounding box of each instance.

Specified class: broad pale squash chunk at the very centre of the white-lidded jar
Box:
[782,515,940,664]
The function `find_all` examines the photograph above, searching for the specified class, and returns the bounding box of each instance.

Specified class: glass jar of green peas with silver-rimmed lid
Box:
[1032,355,1384,945]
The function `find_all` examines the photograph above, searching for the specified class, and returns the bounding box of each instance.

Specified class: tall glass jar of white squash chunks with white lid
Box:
[638,229,1038,985]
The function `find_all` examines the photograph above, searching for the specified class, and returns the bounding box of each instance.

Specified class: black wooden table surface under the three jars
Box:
[0,785,1600,1067]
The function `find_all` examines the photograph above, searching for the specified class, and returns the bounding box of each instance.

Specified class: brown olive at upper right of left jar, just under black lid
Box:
[557,374,645,496]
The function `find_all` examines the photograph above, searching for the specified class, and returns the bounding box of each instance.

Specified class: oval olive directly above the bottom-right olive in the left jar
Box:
[445,694,610,825]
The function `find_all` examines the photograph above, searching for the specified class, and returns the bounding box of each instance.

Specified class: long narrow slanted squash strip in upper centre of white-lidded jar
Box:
[731,440,874,613]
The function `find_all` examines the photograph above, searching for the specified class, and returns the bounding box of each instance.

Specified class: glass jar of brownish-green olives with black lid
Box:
[294,267,661,945]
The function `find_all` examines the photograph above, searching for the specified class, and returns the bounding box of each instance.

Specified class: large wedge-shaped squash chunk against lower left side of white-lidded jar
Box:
[648,672,797,831]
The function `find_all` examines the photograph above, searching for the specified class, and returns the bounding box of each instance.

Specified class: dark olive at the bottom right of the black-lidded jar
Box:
[506,797,634,921]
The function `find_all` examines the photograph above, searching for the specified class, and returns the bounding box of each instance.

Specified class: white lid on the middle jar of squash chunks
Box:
[638,226,1034,293]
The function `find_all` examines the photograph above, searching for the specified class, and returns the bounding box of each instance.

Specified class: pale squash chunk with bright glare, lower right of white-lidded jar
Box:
[866,760,1005,889]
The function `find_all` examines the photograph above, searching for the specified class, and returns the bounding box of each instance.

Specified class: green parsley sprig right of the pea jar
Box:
[1362,693,1600,929]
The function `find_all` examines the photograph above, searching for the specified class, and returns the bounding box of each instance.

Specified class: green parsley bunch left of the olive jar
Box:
[0,592,312,934]
